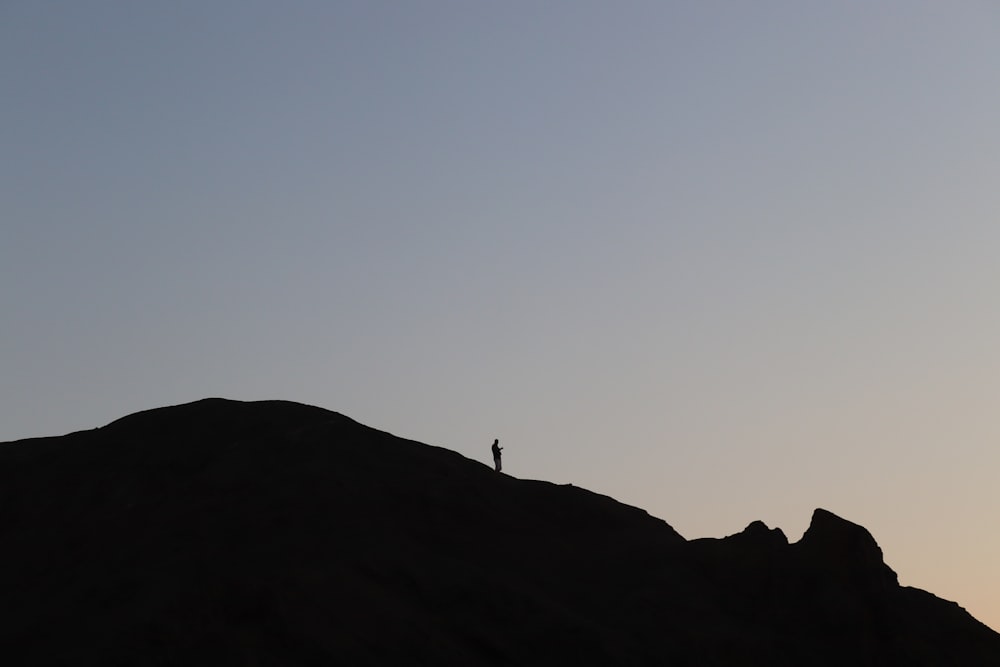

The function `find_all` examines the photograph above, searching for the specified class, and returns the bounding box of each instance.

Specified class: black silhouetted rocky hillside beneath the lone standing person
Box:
[0,399,1000,667]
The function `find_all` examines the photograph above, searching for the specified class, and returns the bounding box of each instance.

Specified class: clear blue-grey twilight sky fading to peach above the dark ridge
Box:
[0,0,1000,629]
